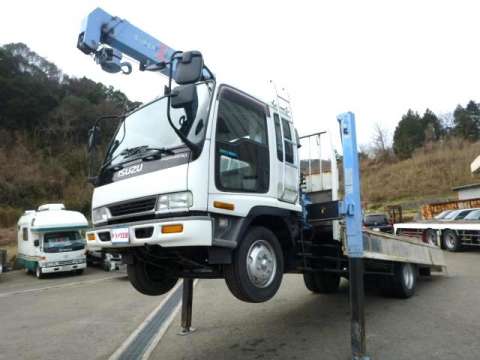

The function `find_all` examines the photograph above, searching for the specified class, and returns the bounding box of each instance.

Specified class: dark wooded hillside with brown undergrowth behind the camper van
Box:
[0,44,138,228]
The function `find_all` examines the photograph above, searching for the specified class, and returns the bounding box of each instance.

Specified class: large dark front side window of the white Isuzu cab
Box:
[215,88,270,193]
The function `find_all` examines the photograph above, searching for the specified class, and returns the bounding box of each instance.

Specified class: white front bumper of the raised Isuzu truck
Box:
[87,216,213,249]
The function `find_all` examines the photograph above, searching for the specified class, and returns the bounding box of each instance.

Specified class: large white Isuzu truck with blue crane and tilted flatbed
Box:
[78,9,445,302]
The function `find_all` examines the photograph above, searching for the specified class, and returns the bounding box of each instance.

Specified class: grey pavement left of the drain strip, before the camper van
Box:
[0,268,163,360]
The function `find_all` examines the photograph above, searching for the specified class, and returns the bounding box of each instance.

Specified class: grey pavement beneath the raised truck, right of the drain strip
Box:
[151,251,480,360]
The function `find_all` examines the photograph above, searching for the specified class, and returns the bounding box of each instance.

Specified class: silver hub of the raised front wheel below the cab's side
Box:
[247,240,277,288]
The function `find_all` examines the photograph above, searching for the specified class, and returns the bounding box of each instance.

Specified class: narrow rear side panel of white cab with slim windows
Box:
[273,113,300,203]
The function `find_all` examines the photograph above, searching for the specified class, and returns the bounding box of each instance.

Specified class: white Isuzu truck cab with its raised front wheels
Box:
[87,62,302,301]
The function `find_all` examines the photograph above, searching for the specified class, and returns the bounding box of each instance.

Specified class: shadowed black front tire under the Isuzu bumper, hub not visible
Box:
[127,259,178,296]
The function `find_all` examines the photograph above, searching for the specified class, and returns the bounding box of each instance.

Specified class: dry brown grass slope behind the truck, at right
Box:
[362,138,480,208]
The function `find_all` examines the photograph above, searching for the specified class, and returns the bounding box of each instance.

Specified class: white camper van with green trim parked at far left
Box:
[17,204,88,278]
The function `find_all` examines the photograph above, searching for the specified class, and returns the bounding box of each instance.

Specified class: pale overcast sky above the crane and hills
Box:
[0,0,480,148]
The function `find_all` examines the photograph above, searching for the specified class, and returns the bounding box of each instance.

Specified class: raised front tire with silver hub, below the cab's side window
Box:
[224,226,284,303]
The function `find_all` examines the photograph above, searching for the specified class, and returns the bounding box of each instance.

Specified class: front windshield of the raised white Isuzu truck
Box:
[104,81,214,167]
